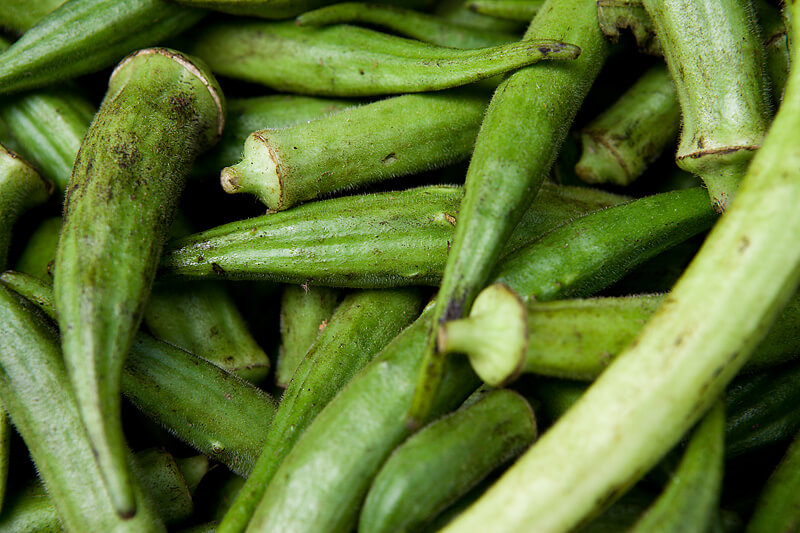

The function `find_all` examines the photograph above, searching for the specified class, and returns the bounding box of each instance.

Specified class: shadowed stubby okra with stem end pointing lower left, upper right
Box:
[575,65,681,186]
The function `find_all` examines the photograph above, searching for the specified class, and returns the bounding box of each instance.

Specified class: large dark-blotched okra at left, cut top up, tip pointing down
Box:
[54,48,224,514]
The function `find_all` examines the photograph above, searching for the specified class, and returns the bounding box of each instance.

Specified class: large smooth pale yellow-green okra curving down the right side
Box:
[445,2,800,533]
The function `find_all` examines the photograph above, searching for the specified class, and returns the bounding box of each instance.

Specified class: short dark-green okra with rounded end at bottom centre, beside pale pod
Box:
[358,389,536,533]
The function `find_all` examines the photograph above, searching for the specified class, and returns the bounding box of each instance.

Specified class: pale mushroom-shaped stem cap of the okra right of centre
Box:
[437,283,528,386]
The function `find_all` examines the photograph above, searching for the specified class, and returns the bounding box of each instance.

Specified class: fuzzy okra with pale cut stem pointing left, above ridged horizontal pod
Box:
[220,91,487,211]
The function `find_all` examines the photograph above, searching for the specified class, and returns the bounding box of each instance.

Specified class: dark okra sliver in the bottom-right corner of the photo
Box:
[747,430,800,533]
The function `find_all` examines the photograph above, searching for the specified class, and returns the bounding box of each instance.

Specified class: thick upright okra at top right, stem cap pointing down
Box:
[643,0,771,212]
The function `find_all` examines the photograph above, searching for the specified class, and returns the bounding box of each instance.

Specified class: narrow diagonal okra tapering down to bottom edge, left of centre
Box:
[219,289,422,533]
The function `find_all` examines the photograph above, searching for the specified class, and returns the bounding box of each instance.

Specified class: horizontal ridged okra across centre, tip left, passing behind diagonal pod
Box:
[161,185,622,288]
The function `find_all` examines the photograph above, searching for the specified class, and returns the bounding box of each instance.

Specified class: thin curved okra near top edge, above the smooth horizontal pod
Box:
[297,2,516,48]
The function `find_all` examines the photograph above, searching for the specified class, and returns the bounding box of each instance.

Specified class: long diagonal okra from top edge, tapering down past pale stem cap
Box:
[409,0,608,424]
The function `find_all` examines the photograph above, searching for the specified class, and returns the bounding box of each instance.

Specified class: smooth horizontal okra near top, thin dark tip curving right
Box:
[186,21,580,96]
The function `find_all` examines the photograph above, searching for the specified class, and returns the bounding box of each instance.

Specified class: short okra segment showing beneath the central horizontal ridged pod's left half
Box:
[275,285,339,388]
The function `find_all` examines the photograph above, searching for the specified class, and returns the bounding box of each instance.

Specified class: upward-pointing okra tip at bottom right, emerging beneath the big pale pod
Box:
[629,400,725,533]
